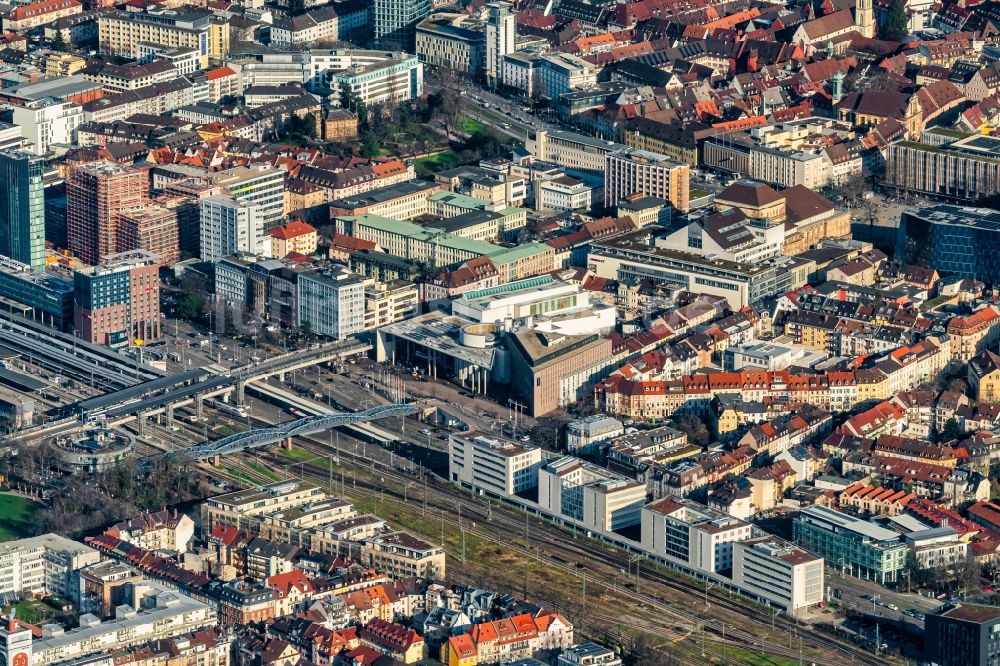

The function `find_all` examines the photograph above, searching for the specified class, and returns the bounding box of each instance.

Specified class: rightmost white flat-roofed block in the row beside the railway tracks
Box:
[733,537,825,613]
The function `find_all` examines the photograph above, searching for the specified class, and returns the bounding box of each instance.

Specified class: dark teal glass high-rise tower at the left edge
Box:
[0,150,45,271]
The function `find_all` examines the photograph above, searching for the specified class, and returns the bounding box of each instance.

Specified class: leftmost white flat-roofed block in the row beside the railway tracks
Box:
[448,432,542,497]
